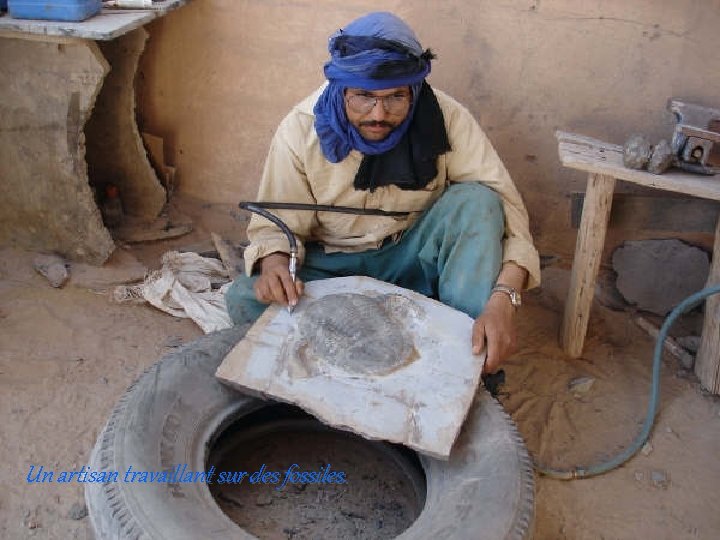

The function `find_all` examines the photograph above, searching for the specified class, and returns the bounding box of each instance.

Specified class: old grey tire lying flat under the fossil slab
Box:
[85,327,534,540]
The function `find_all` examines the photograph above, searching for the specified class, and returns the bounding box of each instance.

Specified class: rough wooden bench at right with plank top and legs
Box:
[556,131,720,394]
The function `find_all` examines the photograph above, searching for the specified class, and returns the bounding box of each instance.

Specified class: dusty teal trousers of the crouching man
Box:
[225,183,505,324]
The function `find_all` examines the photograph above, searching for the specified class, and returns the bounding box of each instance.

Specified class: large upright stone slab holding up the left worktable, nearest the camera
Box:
[0,38,115,264]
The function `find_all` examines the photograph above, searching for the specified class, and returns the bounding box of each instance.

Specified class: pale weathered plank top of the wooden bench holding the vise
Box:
[555,131,720,201]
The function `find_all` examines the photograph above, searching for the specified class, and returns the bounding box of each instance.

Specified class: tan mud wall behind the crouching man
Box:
[140,0,720,255]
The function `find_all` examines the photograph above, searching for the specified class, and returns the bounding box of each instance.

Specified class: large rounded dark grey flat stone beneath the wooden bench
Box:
[612,239,710,316]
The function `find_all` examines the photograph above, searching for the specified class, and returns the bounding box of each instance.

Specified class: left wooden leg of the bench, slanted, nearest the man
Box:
[561,173,615,358]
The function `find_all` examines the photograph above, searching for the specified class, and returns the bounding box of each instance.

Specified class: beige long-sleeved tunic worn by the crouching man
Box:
[245,88,540,288]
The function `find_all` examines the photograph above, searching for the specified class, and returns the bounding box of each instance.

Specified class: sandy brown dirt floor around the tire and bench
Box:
[0,196,720,540]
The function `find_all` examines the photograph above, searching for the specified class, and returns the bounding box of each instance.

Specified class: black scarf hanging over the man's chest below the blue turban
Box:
[353,82,450,192]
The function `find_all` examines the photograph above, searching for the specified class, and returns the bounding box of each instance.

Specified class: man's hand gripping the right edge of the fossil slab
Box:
[472,294,517,373]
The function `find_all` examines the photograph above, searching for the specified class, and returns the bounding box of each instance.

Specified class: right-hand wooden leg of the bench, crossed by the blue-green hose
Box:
[695,213,720,394]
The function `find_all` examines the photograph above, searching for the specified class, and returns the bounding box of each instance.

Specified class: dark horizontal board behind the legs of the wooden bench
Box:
[570,192,720,233]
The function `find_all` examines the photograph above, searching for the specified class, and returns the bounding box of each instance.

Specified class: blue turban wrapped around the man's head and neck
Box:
[314,12,432,163]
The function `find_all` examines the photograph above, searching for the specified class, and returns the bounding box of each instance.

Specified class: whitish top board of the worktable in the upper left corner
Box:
[0,0,188,41]
